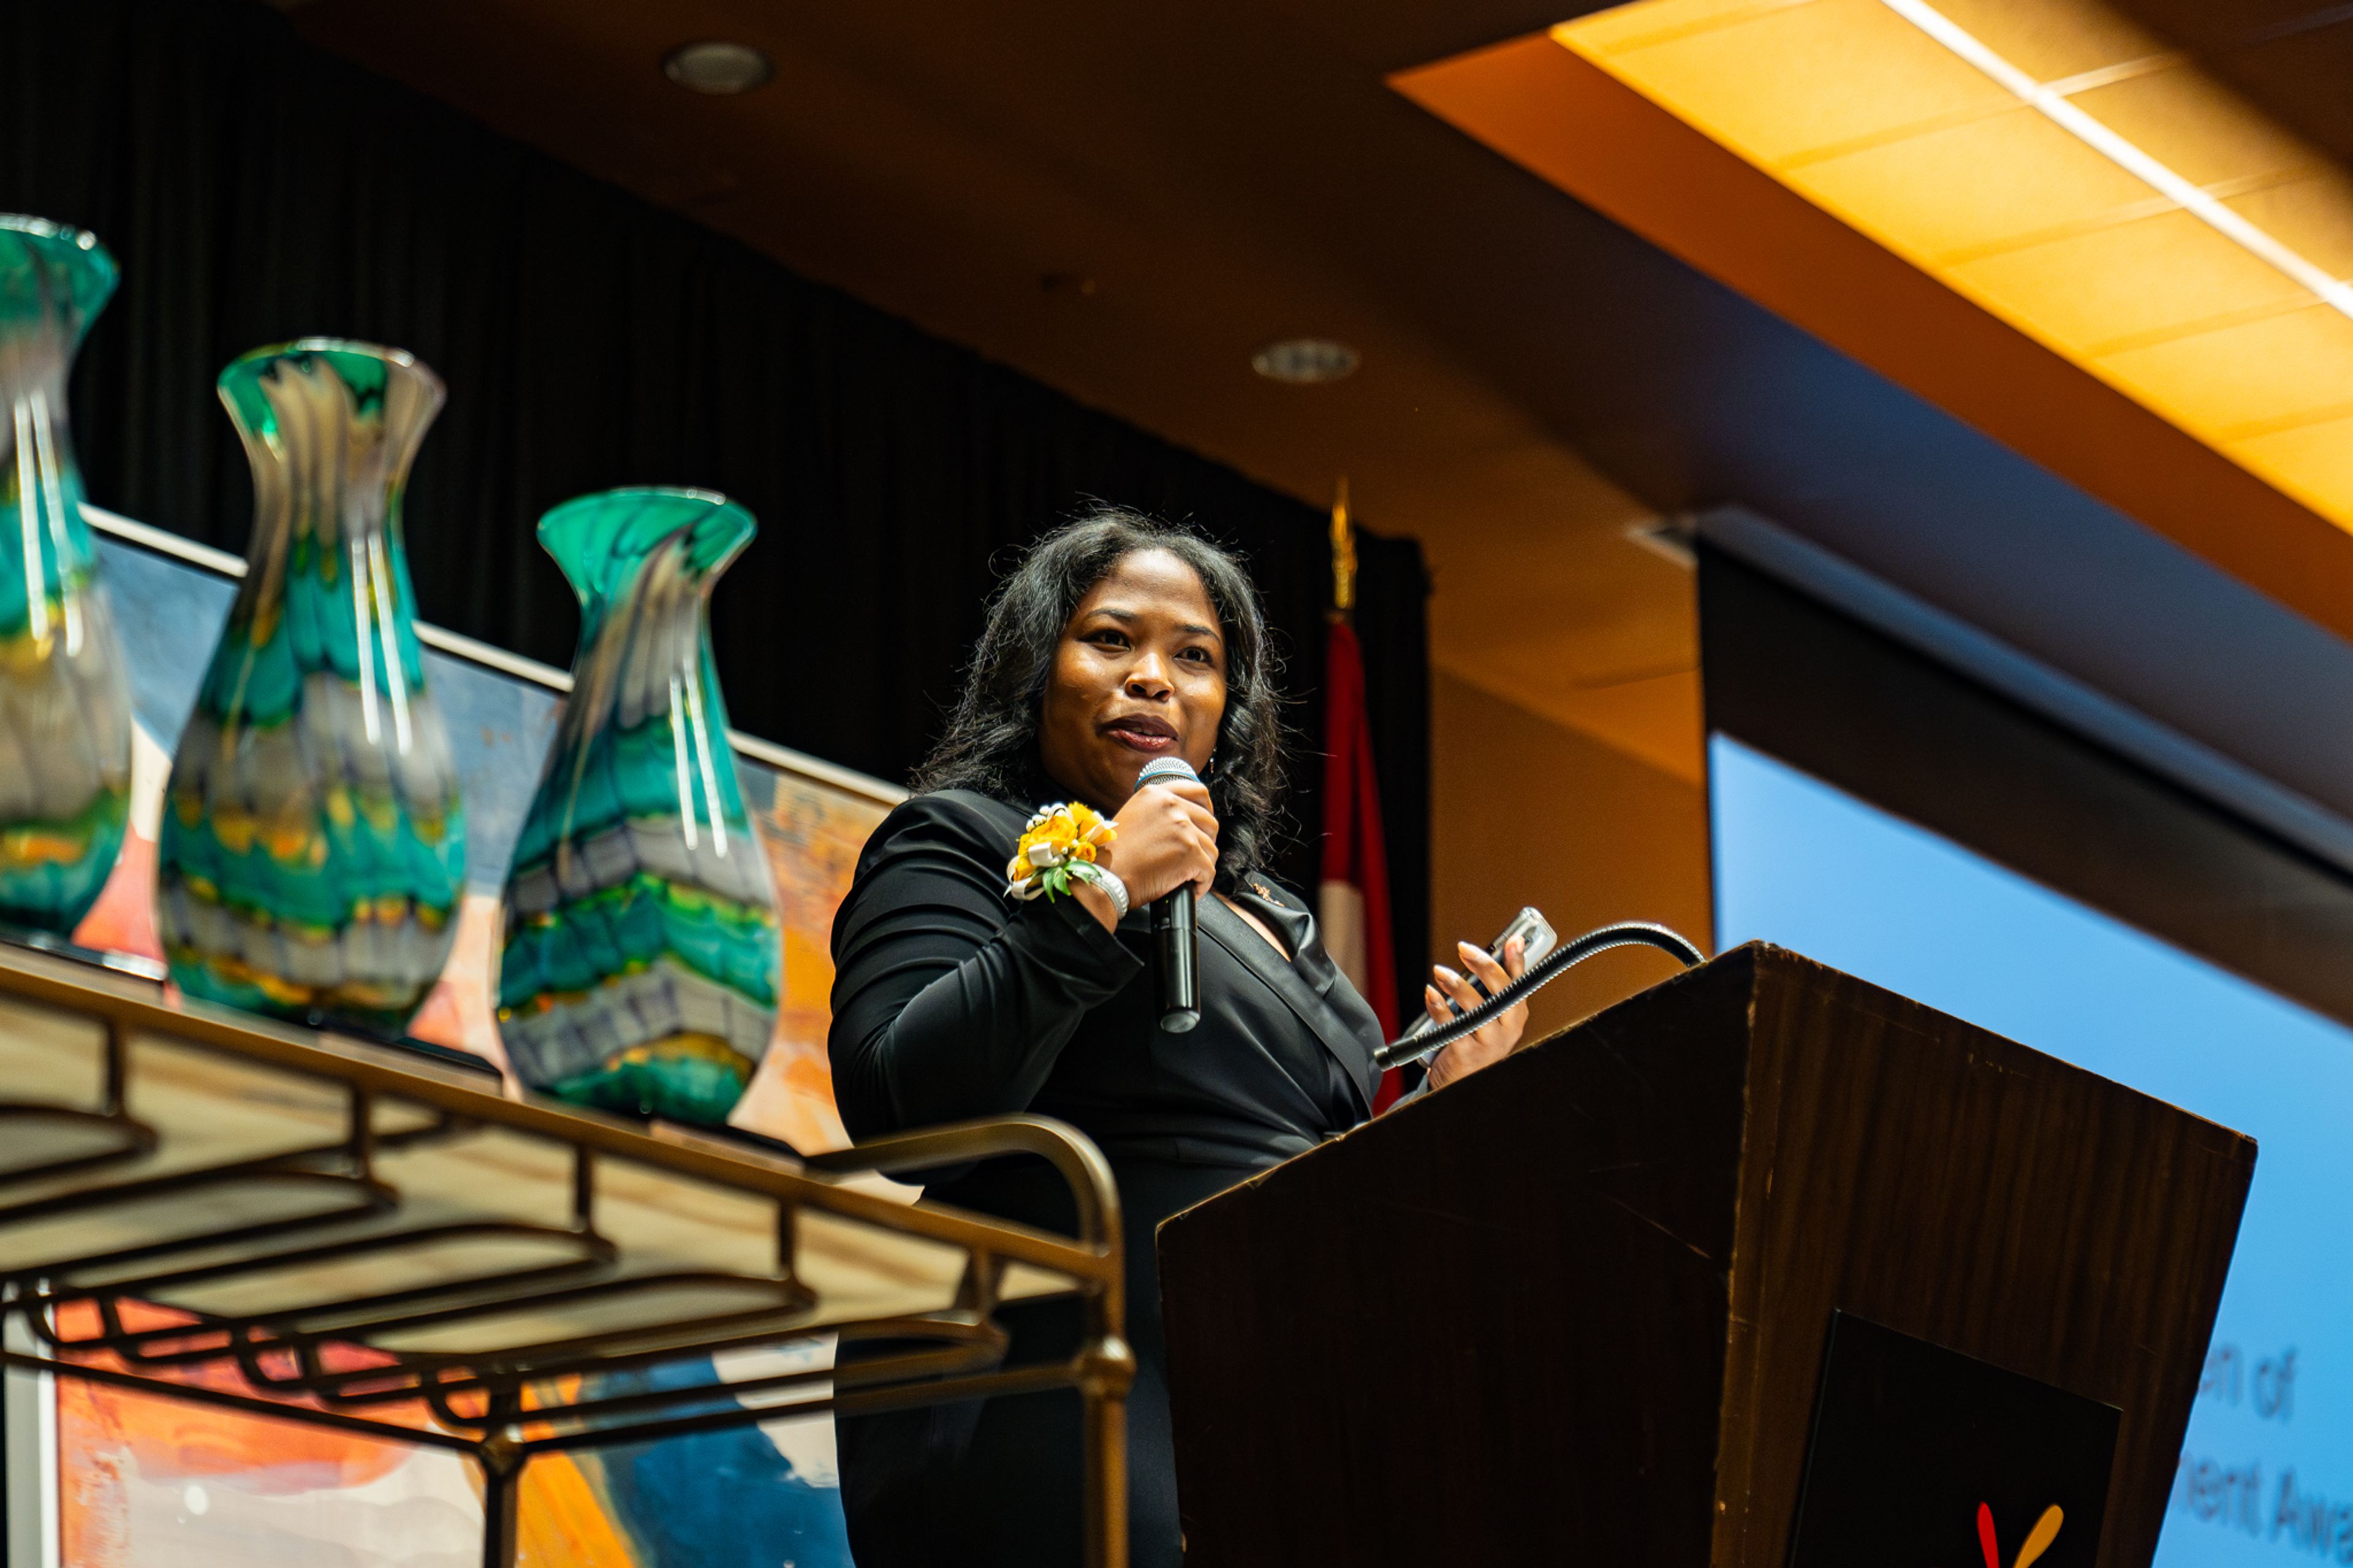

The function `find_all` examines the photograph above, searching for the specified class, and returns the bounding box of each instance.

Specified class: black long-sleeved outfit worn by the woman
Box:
[828,791,1381,1568]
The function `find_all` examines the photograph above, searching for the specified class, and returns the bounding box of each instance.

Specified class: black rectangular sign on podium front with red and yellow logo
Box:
[1788,1311,2123,1568]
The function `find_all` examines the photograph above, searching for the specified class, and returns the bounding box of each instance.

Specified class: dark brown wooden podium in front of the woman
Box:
[1160,947,2254,1568]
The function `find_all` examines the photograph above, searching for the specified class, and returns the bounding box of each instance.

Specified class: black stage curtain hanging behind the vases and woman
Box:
[0,0,1428,1012]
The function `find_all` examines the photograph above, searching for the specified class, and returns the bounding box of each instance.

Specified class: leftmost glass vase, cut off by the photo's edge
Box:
[0,216,132,937]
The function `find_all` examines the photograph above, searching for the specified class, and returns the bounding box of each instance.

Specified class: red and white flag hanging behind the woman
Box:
[1316,617,1398,1112]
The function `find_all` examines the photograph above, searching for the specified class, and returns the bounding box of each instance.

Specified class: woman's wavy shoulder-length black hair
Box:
[915,506,1283,885]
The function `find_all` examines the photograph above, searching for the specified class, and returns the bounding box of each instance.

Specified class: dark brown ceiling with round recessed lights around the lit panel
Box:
[297,0,2353,814]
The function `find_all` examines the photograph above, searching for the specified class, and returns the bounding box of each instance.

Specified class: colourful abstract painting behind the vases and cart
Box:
[56,523,894,1568]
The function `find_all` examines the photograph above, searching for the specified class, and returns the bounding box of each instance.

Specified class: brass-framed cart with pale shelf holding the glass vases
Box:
[0,947,1134,1568]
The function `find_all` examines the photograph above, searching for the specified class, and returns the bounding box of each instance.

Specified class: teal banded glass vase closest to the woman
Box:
[499,490,781,1126]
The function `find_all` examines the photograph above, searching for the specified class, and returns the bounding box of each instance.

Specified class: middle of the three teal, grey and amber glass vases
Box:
[155,336,466,1034]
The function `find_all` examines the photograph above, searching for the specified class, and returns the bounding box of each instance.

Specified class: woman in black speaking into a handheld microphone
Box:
[828,511,1527,1568]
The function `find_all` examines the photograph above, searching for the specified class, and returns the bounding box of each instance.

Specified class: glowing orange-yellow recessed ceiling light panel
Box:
[1390,12,2353,635]
